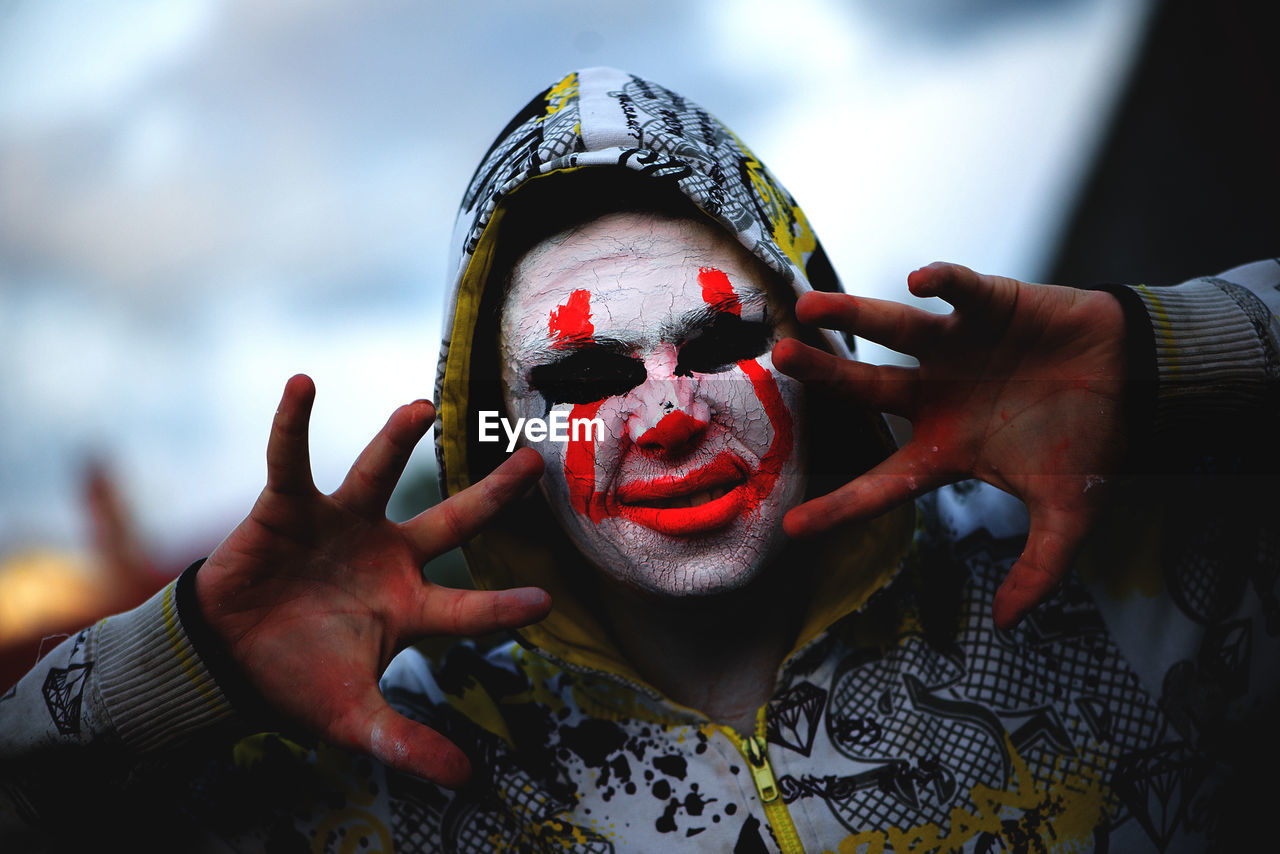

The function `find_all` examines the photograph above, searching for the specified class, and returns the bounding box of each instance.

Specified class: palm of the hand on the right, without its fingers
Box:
[914,268,1123,494]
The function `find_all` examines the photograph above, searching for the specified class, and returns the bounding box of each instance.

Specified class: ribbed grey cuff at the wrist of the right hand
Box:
[1133,279,1267,435]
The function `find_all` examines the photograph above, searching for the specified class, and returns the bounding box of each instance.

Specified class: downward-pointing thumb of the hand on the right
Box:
[991,507,1089,629]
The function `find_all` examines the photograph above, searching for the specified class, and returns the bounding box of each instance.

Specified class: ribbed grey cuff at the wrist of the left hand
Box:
[96,573,232,752]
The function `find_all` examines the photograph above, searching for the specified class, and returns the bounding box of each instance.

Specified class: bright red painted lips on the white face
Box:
[616,451,751,536]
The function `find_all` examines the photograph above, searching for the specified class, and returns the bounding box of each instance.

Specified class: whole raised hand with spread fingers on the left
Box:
[196,375,550,786]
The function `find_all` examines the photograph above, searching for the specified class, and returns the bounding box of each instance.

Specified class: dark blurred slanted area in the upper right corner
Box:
[1044,0,1280,286]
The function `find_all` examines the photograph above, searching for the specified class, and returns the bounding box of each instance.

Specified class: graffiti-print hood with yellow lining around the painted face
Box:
[435,68,914,681]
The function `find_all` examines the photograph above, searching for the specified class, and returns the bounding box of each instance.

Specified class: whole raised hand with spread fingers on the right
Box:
[773,262,1125,627]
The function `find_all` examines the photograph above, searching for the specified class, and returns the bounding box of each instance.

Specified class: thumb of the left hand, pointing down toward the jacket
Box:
[343,686,471,789]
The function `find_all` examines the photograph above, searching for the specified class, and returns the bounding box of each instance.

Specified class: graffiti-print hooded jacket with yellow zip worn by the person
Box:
[0,69,1280,853]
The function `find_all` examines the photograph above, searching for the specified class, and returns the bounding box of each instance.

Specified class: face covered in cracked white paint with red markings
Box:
[499,213,805,595]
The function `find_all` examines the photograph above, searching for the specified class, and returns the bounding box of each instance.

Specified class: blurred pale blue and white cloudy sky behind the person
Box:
[0,0,1149,570]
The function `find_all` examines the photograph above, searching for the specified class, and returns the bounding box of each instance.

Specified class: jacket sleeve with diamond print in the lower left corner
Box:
[0,567,236,848]
